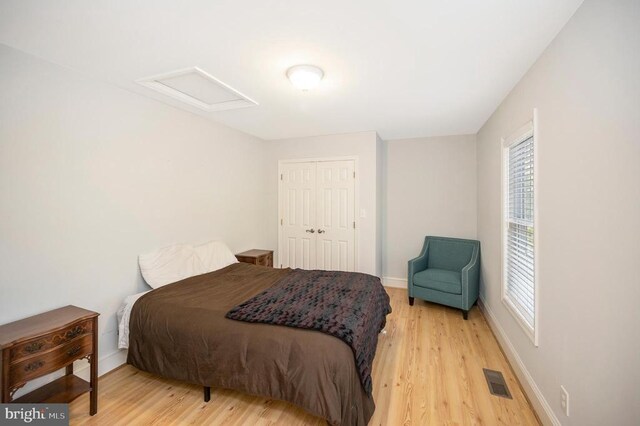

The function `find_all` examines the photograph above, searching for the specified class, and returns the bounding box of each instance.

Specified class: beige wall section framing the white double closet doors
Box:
[264,132,381,275]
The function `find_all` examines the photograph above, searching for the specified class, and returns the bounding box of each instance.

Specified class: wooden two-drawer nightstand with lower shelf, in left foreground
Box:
[0,305,100,415]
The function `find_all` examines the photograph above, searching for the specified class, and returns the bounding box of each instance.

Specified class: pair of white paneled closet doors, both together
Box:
[279,160,356,272]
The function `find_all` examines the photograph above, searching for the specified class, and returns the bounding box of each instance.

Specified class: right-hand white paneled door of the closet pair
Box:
[315,160,355,272]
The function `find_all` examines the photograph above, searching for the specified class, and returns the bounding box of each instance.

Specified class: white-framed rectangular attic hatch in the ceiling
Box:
[136,67,258,112]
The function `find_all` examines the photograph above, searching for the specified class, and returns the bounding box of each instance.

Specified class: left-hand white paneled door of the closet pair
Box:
[279,161,317,269]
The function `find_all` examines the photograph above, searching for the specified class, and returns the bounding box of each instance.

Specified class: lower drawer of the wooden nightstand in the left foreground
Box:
[9,335,93,386]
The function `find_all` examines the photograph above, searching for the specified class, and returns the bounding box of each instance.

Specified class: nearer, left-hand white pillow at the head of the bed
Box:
[138,244,206,288]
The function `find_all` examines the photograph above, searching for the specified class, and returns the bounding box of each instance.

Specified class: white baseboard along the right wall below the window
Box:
[478,297,561,426]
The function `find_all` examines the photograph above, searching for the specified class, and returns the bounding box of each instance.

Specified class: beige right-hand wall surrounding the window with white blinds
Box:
[478,0,640,426]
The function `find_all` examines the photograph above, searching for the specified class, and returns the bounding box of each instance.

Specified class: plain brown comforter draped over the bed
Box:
[127,263,375,425]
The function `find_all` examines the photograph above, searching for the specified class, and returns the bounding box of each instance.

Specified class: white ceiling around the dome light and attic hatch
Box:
[0,0,582,139]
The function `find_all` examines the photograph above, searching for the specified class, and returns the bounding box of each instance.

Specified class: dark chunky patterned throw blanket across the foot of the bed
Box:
[226,269,391,394]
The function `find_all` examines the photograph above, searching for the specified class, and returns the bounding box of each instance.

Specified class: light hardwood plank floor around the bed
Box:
[69,288,539,426]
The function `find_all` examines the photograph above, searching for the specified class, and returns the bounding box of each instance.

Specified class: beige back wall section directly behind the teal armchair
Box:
[383,135,476,287]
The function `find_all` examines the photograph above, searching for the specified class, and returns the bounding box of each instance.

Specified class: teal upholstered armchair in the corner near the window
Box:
[407,237,480,320]
